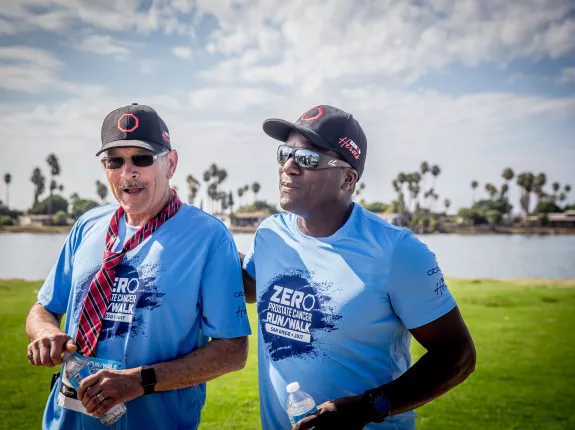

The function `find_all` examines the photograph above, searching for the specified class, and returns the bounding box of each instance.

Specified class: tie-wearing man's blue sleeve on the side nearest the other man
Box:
[200,235,251,339]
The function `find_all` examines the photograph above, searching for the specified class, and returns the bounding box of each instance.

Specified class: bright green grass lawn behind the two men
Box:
[0,279,575,430]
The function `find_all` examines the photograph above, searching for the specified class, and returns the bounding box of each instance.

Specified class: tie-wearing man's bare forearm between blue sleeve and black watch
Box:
[152,336,248,391]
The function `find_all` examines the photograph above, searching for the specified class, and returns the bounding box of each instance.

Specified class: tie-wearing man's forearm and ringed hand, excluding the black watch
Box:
[78,336,248,417]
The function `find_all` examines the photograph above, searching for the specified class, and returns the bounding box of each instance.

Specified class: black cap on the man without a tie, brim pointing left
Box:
[263,105,367,177]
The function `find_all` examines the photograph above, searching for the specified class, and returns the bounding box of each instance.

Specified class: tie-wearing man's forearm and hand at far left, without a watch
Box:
[26,302,76,367]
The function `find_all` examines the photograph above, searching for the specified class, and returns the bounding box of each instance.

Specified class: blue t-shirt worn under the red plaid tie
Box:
[38,204,250,430]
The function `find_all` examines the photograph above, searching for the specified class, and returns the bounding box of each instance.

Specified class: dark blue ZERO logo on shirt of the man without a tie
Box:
[258,272,341,361]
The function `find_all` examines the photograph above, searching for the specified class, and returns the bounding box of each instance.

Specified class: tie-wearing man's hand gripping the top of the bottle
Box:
[28,329,76,367]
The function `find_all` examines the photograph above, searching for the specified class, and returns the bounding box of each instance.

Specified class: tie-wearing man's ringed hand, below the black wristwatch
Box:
[78,367,144,418]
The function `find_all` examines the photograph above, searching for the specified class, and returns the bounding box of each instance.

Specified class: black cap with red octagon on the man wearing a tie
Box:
[96,103,172,156]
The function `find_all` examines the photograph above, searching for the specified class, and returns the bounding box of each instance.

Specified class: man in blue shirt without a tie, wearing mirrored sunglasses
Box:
[242,106,475,430]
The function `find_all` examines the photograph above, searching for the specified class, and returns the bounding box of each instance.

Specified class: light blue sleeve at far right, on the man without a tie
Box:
[387,230,456,329]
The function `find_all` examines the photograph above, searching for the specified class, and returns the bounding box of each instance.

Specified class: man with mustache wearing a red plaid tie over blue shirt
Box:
[26,103,250,429]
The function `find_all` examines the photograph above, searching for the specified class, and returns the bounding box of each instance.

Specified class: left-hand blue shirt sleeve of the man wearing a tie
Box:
[38,220,81,315]
